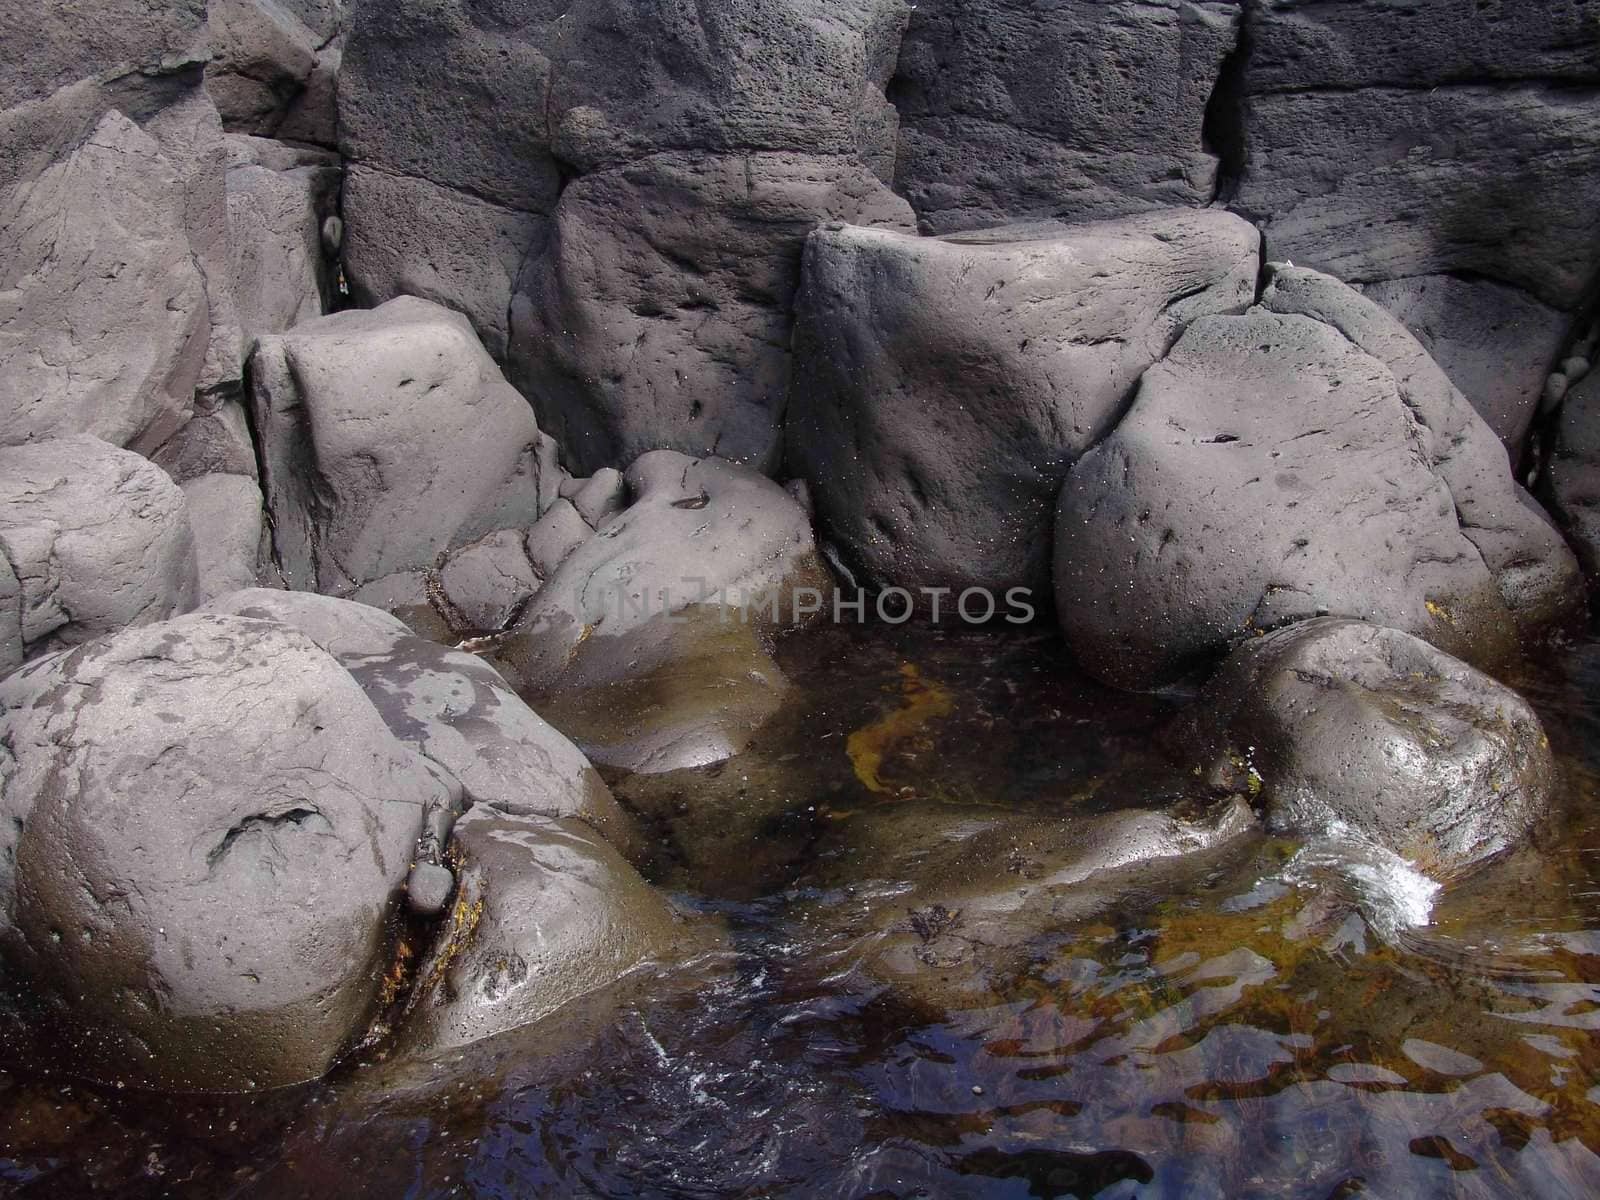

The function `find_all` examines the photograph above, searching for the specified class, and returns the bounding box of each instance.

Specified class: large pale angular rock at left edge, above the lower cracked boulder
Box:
[0,112,211,451]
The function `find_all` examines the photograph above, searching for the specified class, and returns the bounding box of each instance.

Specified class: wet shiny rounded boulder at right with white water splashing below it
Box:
[1189,618,1557,878]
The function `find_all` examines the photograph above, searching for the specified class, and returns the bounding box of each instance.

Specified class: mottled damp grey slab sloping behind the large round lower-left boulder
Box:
[208,589,643,858]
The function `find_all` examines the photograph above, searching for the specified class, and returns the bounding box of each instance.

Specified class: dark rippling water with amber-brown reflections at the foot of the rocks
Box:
[0,629,1600,1200]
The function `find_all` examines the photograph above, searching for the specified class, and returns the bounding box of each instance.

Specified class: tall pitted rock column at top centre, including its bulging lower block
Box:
[339,0,910,472]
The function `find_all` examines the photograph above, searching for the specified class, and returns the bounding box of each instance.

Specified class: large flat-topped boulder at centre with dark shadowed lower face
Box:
[787,211,1259,603]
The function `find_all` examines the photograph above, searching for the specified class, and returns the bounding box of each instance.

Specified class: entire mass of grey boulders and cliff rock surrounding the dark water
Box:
[0,0,1600,1091]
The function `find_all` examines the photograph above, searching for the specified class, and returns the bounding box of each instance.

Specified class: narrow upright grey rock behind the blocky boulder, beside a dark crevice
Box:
[227,134,341,339]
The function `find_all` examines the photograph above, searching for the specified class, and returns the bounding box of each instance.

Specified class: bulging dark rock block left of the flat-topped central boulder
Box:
[510,152,910,472]
